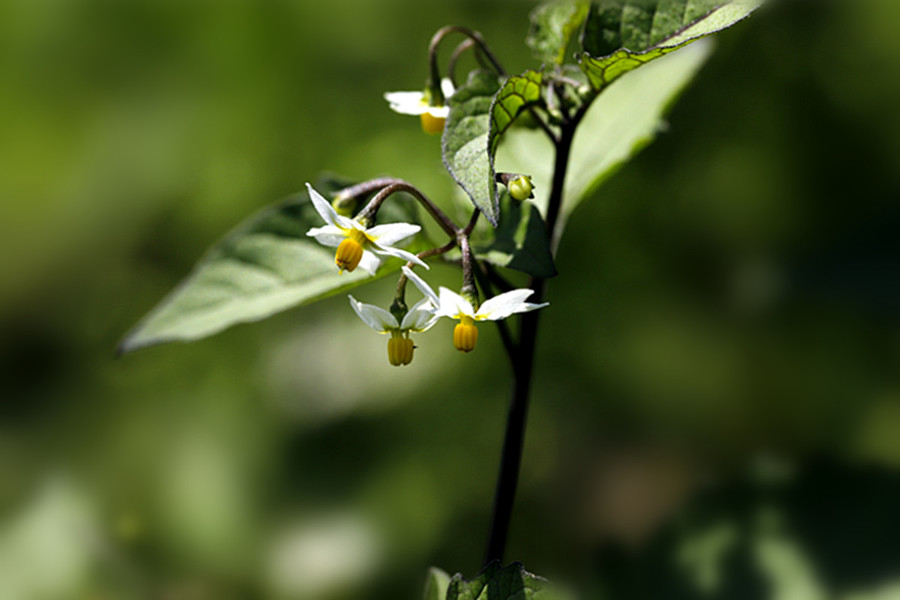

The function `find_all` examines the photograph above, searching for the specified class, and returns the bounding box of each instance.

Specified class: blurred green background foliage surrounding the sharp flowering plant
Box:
[0,0,900,600]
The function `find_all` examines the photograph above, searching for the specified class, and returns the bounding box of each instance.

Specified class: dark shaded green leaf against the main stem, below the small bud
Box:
[473,191,557,279]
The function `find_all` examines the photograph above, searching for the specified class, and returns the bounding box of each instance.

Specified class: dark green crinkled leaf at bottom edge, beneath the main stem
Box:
[447,561,569,600]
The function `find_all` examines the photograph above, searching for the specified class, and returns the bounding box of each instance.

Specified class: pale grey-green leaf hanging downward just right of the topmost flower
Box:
[441,70,500,227]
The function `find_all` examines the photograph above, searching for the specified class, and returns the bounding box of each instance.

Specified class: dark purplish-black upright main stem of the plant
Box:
[484,120,578,564]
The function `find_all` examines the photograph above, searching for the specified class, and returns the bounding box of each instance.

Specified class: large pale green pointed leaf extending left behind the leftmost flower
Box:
[119,180,425,354]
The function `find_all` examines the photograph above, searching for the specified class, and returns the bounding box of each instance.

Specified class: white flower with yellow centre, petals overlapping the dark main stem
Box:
[435,287,549,352]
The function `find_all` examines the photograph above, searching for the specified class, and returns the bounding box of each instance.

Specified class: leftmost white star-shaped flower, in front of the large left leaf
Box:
[306,183,428,275]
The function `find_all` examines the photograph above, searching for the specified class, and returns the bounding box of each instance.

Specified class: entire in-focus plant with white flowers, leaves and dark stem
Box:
[120,0,762,600]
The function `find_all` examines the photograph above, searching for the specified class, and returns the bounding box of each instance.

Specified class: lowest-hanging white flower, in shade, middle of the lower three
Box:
[349,267,438,367]
